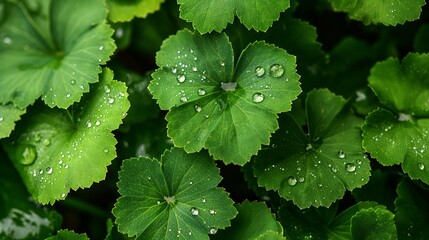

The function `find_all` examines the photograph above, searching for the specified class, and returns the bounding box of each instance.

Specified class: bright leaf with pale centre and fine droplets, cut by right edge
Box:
[362,54,429,183]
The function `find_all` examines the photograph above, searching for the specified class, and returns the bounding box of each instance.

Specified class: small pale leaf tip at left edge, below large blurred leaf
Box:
[0,104,25,139]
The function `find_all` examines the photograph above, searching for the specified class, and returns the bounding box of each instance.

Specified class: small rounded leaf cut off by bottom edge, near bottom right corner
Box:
[351,208,397,240]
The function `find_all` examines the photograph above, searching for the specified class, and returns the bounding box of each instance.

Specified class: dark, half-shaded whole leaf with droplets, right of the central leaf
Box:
[253,89,370,208]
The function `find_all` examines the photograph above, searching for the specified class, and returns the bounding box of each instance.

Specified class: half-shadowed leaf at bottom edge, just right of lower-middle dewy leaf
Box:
[214,200,285,240]
